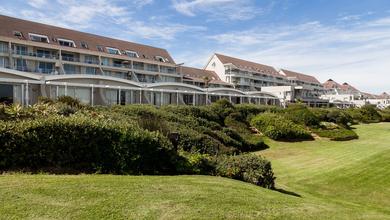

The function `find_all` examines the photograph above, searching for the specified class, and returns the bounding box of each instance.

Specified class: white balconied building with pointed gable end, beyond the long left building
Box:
[205,54,328,106]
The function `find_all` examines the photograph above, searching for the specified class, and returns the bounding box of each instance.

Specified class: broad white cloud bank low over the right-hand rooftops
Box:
[209,17,390,93]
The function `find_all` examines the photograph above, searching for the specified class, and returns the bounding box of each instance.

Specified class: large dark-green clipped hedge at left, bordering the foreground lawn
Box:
[0,116,178,174]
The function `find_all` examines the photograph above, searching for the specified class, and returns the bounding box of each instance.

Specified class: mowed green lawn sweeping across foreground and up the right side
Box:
[0,123,390,219]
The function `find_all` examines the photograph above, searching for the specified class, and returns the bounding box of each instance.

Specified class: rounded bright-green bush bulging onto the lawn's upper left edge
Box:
[251,113,313,141]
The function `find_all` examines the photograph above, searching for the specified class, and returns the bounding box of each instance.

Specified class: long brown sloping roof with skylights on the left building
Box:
[0,15,175,64]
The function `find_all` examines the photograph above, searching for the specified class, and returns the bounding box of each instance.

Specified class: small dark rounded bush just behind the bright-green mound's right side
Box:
[285,104,320,127]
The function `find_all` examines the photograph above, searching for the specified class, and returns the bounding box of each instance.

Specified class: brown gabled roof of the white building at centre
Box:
[215,53,284,77]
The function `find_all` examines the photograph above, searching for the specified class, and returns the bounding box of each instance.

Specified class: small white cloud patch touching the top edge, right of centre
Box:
[172,0,263,20]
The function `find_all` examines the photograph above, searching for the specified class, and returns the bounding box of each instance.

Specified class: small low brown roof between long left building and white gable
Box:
[181,66,230,85]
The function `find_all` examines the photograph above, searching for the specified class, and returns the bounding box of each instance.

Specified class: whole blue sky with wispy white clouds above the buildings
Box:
[0,0,390,93]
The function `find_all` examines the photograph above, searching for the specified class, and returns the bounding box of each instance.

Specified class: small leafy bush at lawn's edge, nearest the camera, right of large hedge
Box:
[216,154,275,189]
